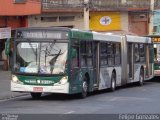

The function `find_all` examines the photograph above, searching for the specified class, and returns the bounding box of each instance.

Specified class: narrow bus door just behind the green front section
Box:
[93,42,100,88]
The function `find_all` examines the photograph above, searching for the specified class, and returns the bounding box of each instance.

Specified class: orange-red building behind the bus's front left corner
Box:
[0,0,41,70]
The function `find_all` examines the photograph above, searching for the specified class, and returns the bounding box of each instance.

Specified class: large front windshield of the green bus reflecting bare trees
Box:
[14,41,68,74]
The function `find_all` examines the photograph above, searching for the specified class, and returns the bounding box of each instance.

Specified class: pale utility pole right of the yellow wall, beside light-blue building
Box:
[149,0,154,35]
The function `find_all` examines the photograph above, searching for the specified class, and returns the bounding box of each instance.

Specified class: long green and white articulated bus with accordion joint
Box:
[5,27,153,99]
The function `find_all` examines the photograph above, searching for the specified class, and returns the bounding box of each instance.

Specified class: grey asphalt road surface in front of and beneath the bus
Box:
[0,77,160,114]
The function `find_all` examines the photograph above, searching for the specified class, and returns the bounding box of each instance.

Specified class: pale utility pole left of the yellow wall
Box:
[83,0,89,30]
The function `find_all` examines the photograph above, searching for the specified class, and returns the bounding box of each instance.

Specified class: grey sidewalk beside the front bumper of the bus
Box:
[0,70,28,100]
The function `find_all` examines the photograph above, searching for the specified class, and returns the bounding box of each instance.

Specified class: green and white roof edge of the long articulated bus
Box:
[16,27,152,43]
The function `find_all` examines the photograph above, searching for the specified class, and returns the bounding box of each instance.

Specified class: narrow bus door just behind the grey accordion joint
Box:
[128,43,134,79]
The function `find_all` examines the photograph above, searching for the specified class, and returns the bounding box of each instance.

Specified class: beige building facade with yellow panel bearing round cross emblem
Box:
[28,0,154,35]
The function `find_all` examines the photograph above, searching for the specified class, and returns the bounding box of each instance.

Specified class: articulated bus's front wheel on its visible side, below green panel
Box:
[80,79,88,98]
